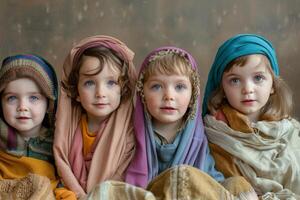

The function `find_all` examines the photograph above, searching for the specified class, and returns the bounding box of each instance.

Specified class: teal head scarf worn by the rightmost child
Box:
[202,34,279,116]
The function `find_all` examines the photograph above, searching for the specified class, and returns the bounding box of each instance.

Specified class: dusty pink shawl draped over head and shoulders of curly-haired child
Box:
[53,36,136,197]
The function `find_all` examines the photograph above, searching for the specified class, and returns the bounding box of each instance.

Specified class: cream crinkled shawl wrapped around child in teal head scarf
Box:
[204,115,300,199]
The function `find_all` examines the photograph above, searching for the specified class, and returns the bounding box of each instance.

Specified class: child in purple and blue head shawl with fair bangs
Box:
[126,47,223,187]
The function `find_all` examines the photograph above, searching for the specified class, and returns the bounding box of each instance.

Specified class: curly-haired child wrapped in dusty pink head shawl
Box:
[54,36,136,197]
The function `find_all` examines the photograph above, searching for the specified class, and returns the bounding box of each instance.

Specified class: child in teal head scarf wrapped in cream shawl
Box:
[203,34,300,199]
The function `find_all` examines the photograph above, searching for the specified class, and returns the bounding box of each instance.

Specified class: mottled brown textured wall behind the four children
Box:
[0,0,300,119]
